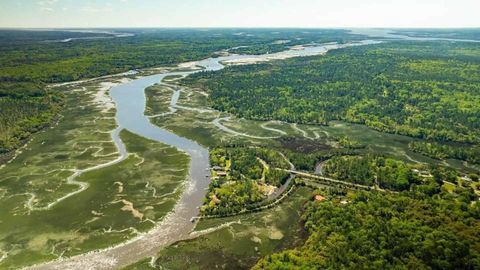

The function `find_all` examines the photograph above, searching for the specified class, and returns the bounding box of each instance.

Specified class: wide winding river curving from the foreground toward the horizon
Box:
[32,40,379,269]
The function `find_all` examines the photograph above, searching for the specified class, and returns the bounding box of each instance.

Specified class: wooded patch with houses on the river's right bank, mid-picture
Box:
[202,146,289,215]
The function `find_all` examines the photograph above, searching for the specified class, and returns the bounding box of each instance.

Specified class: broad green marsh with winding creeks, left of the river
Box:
[0,81,189,269]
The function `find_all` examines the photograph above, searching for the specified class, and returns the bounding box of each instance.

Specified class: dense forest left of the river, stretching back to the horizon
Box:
[0,29,358,160]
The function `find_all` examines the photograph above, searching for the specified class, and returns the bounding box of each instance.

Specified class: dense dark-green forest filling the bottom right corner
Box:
[253,180,480,269]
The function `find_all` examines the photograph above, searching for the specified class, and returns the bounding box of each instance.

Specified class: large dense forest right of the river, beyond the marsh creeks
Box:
[185,42,480,143]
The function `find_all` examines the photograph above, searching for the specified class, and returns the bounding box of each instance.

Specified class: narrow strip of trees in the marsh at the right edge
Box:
[408,141,480,164]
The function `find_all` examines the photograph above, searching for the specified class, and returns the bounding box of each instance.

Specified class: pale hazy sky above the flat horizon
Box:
[0,0,480,28]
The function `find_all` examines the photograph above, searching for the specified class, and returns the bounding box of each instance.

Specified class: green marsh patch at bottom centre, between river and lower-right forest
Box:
[126,188,311,270]
